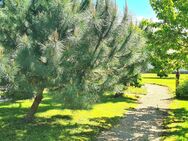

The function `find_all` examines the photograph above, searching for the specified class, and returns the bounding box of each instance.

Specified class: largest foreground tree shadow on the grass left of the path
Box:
[0,110,122,141]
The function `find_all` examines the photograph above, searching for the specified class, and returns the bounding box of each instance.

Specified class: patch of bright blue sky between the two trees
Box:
[116,0,156,19]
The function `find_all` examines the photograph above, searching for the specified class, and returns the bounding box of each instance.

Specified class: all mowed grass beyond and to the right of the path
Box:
[142,74,188,141]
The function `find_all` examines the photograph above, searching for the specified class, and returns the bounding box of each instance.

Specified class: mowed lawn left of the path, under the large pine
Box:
[0,88,146,141]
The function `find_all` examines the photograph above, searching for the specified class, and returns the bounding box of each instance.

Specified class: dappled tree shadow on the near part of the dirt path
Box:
[98,107,169,141]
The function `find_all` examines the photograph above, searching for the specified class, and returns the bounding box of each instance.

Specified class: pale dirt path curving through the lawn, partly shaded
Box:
[98,84,171,141]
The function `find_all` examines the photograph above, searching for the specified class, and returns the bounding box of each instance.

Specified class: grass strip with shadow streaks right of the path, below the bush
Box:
[164,100,188,141]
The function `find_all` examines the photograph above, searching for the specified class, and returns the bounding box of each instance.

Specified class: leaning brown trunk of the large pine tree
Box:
[26,88,44,122]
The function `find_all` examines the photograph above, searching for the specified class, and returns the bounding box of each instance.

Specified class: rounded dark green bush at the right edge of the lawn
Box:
[176,80,188,99]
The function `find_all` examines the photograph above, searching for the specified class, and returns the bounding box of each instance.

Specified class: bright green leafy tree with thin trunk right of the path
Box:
[144,0,188,84]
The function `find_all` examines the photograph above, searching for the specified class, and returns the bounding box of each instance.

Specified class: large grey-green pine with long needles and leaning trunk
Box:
[0,0,146,121]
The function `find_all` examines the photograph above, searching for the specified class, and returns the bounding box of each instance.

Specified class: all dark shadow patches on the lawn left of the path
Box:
[0,96,136,141]
